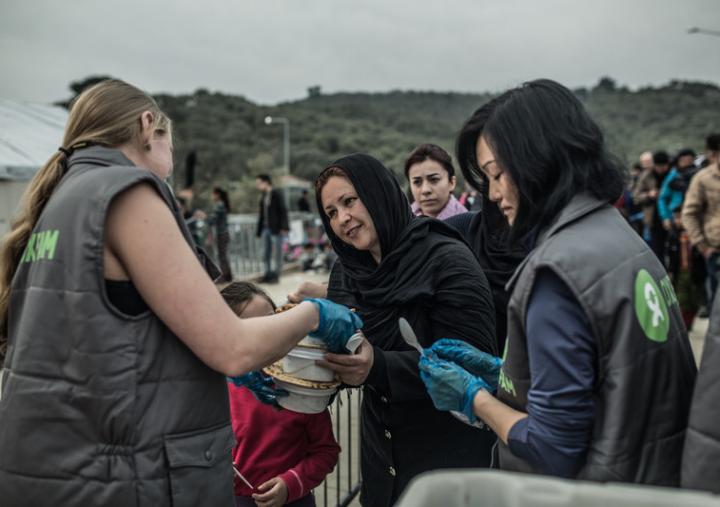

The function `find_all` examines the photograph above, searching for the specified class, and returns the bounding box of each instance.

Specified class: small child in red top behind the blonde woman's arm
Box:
[221,282,340,507]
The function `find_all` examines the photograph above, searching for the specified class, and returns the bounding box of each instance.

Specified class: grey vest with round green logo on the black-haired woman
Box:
[498,195,696,486]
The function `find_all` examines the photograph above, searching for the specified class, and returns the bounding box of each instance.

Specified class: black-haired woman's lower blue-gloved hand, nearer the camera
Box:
[418,354,491,424]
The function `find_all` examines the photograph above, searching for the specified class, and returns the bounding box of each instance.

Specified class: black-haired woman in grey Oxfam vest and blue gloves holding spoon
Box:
[420,80,696,486]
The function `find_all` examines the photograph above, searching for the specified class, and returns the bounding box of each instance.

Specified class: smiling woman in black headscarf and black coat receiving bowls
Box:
[316,154,497,506]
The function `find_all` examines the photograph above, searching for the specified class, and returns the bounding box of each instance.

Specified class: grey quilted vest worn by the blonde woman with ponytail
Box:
[0,147,235,507]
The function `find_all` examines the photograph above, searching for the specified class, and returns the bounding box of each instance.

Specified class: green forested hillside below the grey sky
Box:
[62,78,720,211]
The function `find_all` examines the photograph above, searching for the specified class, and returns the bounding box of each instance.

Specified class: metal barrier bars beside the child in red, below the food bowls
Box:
[314,389,362,507]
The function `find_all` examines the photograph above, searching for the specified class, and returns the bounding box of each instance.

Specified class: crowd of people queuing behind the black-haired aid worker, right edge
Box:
[616,133,720,329]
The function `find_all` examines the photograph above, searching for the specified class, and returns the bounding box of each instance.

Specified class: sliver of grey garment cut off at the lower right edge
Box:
[681,295,720,493]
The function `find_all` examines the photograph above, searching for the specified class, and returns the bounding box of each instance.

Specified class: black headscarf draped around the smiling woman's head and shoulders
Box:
[316,154,496,356]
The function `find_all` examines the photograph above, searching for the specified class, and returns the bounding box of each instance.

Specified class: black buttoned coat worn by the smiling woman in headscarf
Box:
[328,251,497,507]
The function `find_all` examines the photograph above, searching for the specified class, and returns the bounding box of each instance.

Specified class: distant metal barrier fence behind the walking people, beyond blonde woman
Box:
[197,212,323,279]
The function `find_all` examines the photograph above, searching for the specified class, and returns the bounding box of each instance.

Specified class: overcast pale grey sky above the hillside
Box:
[0,0,720,103]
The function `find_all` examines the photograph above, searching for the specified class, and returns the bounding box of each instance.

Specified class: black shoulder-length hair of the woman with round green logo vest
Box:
[456,79,626,239]
